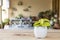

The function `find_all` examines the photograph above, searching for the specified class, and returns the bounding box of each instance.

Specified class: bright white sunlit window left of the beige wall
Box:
[2,0,9,21]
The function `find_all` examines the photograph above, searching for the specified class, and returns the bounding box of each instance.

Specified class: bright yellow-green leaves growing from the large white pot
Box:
[34,19,50,27]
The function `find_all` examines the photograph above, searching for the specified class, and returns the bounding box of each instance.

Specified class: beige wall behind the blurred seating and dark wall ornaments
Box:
[9,0,52,16]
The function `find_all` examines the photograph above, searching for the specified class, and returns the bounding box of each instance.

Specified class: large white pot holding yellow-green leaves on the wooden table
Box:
[34,27,47,38]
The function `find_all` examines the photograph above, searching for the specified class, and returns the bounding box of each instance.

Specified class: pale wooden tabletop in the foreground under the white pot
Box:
[0,29,60,40]
